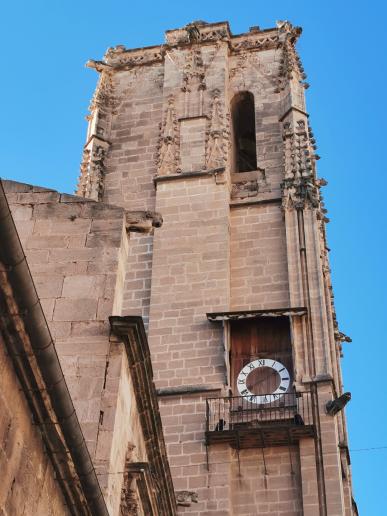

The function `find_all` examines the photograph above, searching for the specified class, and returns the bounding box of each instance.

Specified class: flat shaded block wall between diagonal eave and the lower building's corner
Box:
[5,182,123,458]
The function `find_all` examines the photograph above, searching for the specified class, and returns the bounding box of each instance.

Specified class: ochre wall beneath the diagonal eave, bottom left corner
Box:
[0,335,69,516]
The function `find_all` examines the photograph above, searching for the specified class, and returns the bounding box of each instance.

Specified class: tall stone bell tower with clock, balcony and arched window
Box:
[78,21,357,516]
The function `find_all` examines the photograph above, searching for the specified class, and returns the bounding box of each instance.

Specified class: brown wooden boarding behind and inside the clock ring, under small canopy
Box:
[230,317,293,396]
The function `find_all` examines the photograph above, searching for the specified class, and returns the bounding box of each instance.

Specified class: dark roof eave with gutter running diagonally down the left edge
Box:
[0,181,108,516]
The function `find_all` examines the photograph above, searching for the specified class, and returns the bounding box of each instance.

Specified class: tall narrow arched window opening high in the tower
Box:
[231,91,257,172]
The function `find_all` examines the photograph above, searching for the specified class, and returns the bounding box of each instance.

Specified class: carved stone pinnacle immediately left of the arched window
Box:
[206,89,230,170]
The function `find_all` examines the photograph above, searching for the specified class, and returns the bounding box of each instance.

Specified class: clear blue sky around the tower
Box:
[0,0,387,516]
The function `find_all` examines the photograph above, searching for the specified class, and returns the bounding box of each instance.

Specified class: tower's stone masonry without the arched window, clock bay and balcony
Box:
[77,22,356,516]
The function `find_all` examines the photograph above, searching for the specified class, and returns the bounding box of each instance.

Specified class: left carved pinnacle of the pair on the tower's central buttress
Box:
[157,95,180,176]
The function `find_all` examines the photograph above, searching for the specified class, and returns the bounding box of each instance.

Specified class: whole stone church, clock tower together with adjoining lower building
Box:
[0,21,357,516]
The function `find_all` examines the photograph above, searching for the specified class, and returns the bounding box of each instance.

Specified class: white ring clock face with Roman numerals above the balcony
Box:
[237,358,290,405]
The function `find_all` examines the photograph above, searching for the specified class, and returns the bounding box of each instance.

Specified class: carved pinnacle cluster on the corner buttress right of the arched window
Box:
[281,119,320,209]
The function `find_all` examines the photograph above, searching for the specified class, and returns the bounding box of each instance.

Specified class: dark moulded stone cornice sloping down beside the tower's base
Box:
[109,316,176,516]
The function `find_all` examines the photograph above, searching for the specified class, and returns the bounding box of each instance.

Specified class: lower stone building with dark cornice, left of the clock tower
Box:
[4,181,175,516]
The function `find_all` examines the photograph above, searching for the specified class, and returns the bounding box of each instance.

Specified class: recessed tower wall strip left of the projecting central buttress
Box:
[95,64,163,324]
